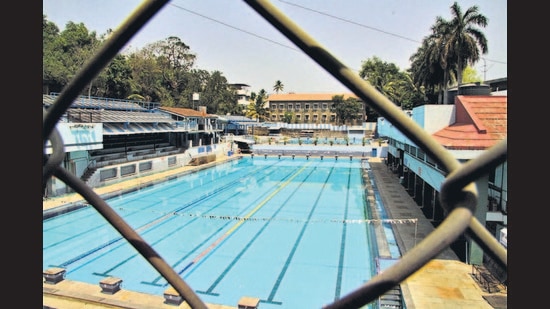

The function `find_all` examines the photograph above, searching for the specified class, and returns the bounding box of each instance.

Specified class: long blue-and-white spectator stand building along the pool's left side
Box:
[43,94,230,197]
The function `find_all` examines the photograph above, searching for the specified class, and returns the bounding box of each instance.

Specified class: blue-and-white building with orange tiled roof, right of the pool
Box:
[377,85,509,270]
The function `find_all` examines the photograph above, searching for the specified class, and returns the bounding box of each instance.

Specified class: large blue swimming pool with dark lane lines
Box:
[43,157,398,308]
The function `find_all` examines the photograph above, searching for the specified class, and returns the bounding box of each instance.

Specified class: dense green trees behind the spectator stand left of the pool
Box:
[42,15,239,114]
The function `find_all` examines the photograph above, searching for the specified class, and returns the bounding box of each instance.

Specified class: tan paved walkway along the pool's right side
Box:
[369,158,507,309]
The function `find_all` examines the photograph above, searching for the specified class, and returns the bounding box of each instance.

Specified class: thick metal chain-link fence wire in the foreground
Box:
[42,0,508,309]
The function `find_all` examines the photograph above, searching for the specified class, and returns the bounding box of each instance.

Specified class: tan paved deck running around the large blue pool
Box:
[42,156,507,309]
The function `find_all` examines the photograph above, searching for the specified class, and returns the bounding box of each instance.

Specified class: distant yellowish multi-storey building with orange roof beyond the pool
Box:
[266,93,366,125]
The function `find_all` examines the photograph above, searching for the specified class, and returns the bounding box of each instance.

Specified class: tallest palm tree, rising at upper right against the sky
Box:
[437,2,488,97]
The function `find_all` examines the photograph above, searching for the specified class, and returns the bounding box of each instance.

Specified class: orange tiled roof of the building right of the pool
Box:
[432,95,508,150]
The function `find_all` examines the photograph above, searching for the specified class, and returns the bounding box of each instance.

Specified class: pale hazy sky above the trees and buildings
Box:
[42,0,508,94]
